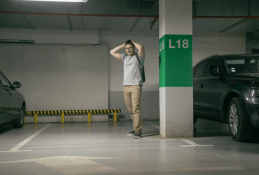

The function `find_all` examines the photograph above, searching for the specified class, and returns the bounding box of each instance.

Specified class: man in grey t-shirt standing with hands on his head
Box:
[110,40,145,139]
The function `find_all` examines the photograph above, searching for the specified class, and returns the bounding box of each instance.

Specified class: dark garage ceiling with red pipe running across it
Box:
[0,0,259,32]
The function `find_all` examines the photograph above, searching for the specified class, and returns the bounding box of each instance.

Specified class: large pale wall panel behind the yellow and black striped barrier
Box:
[0,44,108,121]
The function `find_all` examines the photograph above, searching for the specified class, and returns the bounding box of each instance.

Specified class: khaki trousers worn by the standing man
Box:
[123,85,142,134]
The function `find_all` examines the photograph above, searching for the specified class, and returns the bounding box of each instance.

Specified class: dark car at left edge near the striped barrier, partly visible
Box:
[0,71,26,128]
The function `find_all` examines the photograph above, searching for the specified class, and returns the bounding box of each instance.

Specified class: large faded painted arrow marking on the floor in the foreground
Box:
[0,156,247,175]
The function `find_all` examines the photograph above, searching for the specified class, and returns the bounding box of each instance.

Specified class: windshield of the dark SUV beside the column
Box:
[223,55,259,74]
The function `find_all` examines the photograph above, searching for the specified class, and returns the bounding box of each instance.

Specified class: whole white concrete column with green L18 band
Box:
[159,0,193,138]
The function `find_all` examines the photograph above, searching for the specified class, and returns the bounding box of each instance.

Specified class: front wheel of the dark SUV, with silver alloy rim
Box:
[228,97,253,142]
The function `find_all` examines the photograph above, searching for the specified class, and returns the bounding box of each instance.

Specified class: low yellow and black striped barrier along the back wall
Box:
[26,109,121,123]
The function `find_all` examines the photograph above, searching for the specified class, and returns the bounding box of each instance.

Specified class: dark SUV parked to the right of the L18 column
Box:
[193,55,259,141]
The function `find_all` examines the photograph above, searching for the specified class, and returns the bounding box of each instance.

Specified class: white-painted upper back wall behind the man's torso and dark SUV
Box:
[0,29,246,91]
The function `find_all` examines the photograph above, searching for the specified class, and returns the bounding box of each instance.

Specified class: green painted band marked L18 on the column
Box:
[159,35,193,87]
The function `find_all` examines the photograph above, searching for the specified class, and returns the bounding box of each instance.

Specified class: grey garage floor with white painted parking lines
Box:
[0,120,259,175]
